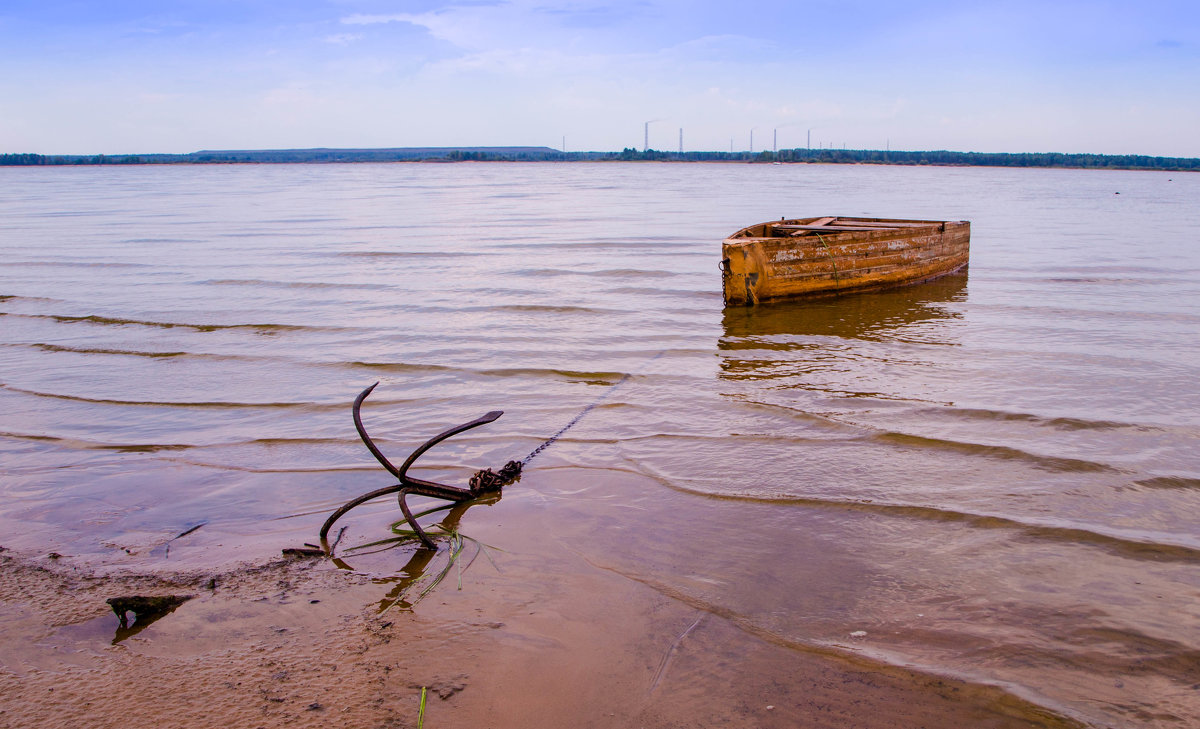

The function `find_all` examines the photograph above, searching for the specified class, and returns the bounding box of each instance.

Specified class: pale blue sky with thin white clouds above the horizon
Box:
[0,0,1200,157]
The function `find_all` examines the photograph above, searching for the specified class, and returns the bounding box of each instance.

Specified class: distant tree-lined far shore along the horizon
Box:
[0,146,1200,171]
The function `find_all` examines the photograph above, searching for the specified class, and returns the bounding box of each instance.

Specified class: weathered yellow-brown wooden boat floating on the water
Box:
[721,217,971,306]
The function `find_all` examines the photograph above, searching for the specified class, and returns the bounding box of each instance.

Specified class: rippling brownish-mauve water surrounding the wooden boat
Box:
[0,163,1200,727]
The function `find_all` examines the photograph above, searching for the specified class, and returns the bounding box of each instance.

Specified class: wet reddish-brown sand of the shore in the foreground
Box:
[0,469,1079,729]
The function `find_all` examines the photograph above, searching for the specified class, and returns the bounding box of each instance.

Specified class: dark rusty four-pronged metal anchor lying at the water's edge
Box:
[320,382,521,555]
